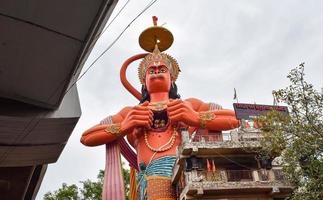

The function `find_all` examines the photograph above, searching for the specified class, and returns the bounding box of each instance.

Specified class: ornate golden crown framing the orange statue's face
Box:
[138,44,180,85]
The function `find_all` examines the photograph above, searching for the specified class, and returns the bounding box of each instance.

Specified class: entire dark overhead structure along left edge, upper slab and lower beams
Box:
[0,0,117,200]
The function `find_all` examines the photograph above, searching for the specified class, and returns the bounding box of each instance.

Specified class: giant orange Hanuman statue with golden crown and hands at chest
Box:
[81,17,239,200]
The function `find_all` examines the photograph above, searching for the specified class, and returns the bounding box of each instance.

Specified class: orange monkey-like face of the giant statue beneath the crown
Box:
[145,62,171,93]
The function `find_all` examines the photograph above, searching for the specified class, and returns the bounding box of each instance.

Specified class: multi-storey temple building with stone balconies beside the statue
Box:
[172,104,292,200]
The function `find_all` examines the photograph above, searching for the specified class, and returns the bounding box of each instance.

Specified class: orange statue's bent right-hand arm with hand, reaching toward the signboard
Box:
[167,98,239,131]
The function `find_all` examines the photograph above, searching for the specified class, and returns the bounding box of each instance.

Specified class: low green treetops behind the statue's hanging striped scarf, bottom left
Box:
[44,163,130,200]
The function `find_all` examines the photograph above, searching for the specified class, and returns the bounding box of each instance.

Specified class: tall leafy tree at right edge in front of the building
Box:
[260,63,323,200]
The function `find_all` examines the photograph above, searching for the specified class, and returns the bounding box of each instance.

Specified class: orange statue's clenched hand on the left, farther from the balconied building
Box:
[120,102,153,133]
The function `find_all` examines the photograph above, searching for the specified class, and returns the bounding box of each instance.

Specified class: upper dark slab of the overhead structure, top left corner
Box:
[0,0,117,109]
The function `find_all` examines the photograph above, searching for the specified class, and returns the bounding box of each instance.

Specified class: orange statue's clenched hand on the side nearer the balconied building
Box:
[167,99,199,126]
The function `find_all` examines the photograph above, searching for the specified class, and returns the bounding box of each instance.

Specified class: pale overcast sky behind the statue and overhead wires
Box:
[37,0,323,199]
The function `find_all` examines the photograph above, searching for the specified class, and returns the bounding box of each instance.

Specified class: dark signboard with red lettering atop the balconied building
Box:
[233,103,288,120]
